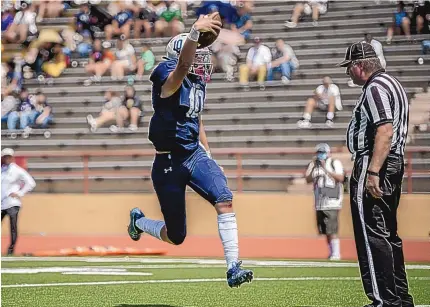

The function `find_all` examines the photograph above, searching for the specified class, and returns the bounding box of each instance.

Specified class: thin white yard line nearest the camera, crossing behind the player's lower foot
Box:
[1,277,430,288]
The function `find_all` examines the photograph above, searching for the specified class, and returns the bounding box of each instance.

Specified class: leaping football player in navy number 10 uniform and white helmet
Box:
[128,15,253,287]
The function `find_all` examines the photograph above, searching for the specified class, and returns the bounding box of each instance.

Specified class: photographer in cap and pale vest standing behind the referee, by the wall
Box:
[305,143,345,260]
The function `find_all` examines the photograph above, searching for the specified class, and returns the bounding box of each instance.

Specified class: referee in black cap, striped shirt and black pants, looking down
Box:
[339,42,414,307]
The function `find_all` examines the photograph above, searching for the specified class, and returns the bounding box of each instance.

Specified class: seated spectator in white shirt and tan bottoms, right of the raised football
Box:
[239,37,272,90]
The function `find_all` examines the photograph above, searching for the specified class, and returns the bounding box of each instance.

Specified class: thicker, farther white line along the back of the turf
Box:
[2,257,430,270]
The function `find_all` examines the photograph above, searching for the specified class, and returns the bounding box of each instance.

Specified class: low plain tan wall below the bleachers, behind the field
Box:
[2,193,430,240]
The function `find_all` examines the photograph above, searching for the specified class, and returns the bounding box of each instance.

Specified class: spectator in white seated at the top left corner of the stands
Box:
[4,1,38,43]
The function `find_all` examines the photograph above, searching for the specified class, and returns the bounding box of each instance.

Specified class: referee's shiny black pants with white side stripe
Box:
[350,155,414,307]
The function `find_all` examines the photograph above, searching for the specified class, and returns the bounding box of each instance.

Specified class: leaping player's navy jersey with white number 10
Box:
[148,59,206,153]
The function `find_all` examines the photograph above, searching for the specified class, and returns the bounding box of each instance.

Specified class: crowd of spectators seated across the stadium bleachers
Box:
[1,0,430,136]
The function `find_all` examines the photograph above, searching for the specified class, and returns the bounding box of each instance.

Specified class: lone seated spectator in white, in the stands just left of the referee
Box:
[297,76,342,128]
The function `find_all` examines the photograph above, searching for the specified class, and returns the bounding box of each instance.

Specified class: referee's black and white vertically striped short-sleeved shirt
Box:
[346,70,409,156]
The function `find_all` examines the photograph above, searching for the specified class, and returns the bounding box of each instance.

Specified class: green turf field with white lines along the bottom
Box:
[1,258,430,307]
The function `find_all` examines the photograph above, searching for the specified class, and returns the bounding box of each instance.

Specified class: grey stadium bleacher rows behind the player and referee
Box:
[2,1,430,192]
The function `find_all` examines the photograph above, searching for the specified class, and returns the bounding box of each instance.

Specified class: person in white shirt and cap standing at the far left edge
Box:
[1,148,36,255]
